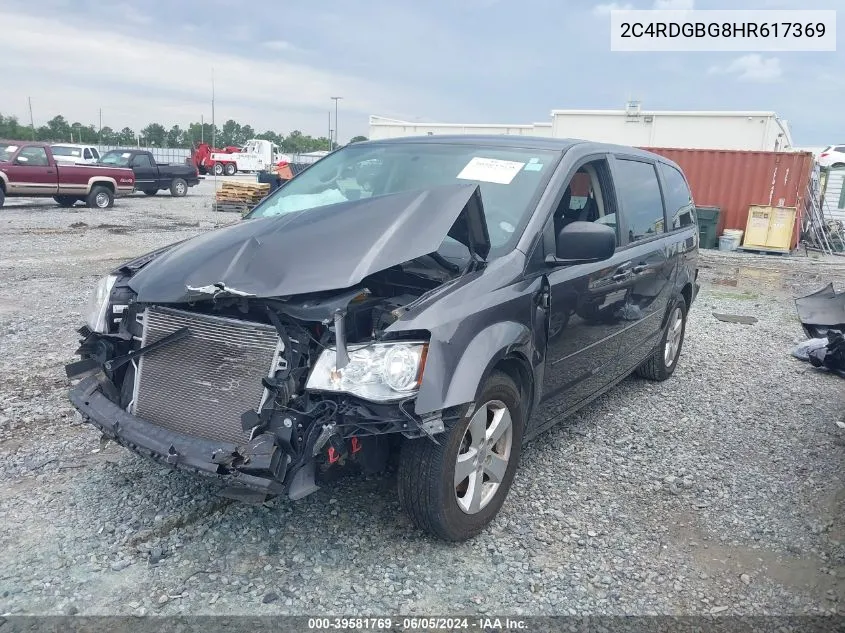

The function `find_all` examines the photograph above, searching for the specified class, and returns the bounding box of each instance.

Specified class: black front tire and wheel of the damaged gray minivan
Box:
[398,373,525,541]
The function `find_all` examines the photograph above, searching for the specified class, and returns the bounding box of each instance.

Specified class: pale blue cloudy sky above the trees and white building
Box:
[0,0,845,146]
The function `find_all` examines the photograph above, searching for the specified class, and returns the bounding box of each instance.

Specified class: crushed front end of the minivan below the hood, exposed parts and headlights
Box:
[66,269,457,502]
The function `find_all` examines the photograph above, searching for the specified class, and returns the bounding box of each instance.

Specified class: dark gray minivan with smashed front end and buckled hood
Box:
[67,136,698,540]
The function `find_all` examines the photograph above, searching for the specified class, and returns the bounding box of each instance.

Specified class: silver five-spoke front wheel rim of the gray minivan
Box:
[455,400,513,514]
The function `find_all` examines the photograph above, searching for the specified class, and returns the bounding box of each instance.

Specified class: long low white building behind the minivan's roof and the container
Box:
[370,102,792,151]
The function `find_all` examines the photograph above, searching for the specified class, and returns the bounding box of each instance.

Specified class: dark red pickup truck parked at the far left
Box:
[0,142,135,209]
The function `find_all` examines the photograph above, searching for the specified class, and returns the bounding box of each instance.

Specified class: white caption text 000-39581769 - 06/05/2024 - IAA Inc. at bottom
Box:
[308,616,527,631]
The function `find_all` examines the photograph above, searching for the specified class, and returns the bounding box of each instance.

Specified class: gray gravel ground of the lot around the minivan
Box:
[0,182,845,615]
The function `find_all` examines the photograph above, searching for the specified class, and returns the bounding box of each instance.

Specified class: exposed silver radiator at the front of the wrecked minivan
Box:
[132,308,281,444]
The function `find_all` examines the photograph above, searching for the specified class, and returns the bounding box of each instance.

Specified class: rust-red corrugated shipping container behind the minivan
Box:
[643,147,814,248]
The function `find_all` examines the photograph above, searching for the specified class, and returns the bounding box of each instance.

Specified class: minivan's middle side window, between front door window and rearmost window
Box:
[616,159,664,242]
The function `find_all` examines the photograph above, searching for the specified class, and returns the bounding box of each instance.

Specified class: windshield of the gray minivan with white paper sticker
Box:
[247,142,560,250]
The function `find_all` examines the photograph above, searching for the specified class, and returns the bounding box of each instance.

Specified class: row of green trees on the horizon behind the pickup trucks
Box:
[0,113,367,154]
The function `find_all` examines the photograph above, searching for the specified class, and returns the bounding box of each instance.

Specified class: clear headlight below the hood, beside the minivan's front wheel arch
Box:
[305,341,428,402]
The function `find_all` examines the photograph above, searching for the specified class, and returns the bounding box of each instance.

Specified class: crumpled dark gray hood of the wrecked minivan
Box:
[129,184,490,303]
